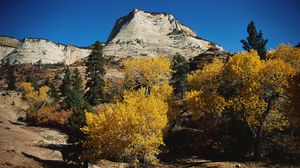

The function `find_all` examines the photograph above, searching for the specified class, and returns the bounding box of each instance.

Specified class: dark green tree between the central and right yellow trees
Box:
[171,53,190,98]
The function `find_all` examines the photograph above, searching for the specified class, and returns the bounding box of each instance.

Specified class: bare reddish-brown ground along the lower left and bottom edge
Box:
[0,91,298,168]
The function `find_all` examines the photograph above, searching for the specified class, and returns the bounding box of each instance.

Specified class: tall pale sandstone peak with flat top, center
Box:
[103,9,223,58]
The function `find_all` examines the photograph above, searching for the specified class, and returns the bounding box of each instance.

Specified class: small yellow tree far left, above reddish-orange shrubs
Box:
[21,82,49,120]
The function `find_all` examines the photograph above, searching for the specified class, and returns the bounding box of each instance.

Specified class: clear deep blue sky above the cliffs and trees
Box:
[0,0,300,52]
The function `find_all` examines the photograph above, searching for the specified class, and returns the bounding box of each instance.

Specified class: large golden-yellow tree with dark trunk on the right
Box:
[187,50,294,157]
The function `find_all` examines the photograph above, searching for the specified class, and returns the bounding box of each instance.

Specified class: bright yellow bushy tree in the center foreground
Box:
[82,85,168,164]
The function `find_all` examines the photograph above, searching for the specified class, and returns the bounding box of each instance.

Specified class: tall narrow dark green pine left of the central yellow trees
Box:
[85,41,105,105]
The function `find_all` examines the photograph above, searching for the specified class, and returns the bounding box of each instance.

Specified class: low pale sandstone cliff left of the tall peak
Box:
[4,38,91,64]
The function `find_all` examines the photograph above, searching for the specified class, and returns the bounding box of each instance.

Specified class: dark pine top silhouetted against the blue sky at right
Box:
[241,21,268,60]
